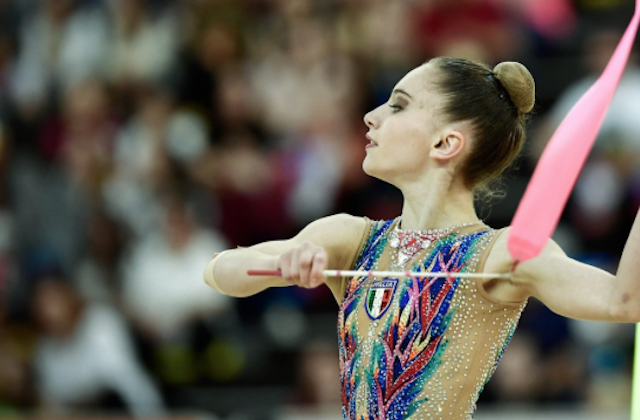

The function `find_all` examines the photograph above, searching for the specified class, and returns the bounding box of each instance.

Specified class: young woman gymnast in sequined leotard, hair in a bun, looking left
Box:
[205,58,640,420]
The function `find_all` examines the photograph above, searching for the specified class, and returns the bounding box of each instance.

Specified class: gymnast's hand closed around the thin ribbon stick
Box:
[278,242,329,289]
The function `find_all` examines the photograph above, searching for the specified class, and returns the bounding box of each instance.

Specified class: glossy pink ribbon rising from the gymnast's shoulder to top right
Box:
[507,0,640,262]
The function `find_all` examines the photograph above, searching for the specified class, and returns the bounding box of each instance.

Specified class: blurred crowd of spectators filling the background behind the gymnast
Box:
[0,0,640,420]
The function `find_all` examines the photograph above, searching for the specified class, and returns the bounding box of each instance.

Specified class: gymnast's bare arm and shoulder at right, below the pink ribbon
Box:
[485,219,640,323]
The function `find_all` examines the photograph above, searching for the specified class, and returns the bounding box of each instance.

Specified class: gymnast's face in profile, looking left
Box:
[362,64,450,185]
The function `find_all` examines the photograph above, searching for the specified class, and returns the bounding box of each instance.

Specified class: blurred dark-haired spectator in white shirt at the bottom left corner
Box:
[33,278,163,417]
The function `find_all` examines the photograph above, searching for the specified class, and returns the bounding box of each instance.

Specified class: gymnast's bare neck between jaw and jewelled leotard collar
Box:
[401,170,478,230]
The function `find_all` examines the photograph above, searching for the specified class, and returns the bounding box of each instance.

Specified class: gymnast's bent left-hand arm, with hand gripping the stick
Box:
[204,214,367,297]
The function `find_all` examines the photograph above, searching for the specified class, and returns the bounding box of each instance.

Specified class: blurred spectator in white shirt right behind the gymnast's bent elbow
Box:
[123,190,230,343]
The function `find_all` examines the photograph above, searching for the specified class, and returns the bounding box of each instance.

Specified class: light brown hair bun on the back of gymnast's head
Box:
[493,61,535,114]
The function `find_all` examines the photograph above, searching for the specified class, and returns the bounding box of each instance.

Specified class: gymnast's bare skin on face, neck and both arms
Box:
[204,64,640,323]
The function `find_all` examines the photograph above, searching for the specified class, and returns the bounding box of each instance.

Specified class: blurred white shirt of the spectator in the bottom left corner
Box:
[35,305,164,417]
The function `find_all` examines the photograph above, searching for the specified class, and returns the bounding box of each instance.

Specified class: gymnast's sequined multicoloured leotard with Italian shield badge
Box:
[330,219,526,420]
